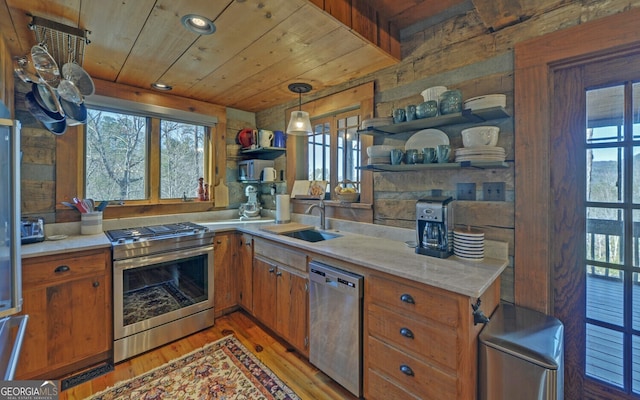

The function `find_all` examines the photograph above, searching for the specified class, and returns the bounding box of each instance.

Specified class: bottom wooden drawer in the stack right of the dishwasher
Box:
[367,336,457,399]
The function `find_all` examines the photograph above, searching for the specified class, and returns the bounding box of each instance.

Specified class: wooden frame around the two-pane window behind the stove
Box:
[51,80,228,222]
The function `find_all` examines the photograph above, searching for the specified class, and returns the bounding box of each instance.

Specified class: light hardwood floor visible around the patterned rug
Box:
[60,311,356,400]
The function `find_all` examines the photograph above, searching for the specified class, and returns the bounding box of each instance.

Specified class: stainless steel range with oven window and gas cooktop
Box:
[106,222,214,362]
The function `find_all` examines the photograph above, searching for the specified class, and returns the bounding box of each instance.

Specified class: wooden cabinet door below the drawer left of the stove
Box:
[16,275,113,379]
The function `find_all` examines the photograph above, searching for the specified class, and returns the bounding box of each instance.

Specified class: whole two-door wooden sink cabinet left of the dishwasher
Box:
[253,238,309,355]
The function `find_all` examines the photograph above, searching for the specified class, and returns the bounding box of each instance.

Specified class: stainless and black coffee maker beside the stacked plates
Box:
[416,196,453,258]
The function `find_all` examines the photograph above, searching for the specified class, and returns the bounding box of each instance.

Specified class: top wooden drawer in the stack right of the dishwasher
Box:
[365,275,458,327]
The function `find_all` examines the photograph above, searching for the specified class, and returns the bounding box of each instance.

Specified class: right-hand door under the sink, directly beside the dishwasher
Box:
[276,268,309,354]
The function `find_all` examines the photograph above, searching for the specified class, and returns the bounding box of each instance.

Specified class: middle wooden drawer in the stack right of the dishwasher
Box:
[367,305,458,374]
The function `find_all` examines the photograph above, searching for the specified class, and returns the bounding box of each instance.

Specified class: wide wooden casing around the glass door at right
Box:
[514,9,640,314]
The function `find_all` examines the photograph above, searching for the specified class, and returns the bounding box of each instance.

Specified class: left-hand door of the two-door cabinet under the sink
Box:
[253,257,277,329]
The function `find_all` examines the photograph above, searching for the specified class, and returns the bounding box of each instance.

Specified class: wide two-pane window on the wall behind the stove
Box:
[84,108,209,203]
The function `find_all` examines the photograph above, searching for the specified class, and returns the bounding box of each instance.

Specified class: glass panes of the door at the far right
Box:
[585,81,640,394]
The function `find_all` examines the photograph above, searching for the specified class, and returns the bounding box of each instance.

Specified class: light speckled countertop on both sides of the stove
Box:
[21,217,507,298]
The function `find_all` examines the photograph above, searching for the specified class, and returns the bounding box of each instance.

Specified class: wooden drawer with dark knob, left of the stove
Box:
[22,251,107,285]
